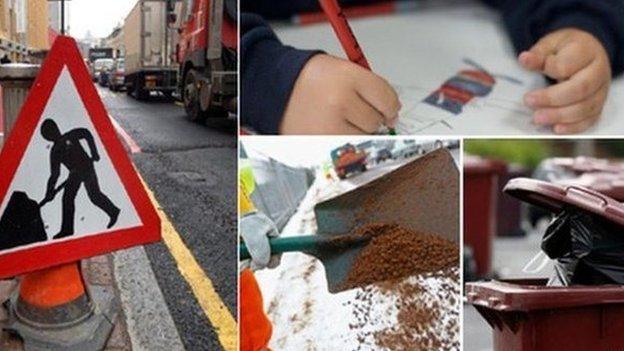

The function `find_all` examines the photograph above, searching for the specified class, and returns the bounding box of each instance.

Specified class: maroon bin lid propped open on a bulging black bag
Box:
[503,178,624,225]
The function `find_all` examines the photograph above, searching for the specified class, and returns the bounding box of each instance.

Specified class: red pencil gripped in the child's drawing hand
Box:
[319,0,371,70]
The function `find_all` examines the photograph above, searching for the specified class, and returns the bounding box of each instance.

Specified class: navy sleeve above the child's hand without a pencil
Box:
[484,0,624,76]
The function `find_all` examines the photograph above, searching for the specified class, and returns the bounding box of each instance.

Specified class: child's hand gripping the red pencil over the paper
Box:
[280,55,401,134]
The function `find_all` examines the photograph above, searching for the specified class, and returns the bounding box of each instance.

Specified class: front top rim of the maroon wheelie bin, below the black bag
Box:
[466,279,624,312]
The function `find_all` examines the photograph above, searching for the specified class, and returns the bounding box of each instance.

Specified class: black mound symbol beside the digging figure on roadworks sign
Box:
[0,191,48,251]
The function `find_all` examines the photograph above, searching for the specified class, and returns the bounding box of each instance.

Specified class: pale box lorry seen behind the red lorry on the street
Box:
[123,0,177,100]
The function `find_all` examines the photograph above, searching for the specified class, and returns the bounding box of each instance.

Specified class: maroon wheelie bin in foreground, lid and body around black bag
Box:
[466,178,624,351]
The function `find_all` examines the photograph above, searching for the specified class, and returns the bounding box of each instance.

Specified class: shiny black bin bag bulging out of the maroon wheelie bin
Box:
[541,207,624,286]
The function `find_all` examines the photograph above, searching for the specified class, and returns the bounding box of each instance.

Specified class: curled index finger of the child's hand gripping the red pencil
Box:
[355,67,401,118]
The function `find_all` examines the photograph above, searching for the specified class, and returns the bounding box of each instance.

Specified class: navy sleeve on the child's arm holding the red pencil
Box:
[240,13,320,134]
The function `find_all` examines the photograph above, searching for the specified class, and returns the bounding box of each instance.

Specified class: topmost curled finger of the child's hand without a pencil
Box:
[544,42,595,80]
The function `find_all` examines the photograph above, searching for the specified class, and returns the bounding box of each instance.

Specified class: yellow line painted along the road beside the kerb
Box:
[141,179,238,351]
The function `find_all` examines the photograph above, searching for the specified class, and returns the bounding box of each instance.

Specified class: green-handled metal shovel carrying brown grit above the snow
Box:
[239,149,459,293]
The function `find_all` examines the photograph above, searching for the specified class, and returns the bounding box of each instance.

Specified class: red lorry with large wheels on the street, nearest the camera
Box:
[173,0,238,122]
